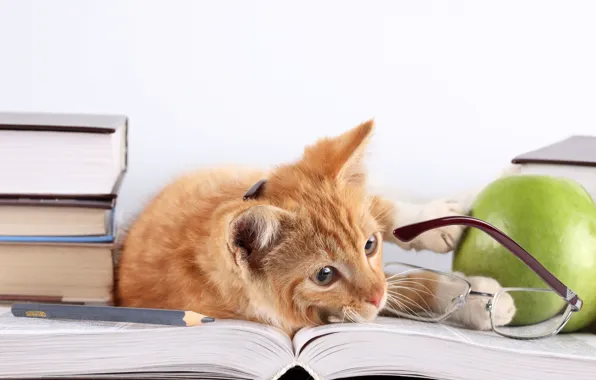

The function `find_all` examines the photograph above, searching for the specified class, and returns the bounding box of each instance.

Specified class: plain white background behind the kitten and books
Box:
[0,0,596,272]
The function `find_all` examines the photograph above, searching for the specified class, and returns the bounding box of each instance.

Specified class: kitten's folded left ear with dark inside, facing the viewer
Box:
[228,205,292,269]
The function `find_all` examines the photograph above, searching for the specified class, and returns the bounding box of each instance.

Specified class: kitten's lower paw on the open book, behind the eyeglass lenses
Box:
[450,276,516,331]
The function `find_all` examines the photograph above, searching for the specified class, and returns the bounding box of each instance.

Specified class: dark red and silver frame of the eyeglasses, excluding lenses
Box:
[388,215,583,339]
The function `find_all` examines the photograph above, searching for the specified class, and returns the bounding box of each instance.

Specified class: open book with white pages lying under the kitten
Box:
[0,307,596,380]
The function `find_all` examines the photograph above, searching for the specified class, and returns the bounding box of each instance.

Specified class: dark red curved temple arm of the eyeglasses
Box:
[393,216,582,311]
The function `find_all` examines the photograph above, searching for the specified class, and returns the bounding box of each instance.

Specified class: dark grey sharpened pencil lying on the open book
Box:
[11,302,214,327]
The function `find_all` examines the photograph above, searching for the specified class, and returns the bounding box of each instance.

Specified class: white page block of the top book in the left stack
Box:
[0,130,120,194]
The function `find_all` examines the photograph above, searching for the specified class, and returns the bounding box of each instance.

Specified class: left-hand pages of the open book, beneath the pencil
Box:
[0,306,294,379]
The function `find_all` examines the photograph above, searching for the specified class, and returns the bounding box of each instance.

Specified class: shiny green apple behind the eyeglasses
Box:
[453,175,596,332]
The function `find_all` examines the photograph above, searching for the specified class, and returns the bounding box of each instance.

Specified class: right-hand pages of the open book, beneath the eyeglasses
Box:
[294,318,596,380]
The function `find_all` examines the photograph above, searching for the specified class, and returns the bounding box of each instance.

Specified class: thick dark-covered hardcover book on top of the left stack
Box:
[0,112,128,198]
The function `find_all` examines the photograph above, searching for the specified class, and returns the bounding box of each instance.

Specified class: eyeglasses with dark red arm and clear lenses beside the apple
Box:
[385,216,582,339]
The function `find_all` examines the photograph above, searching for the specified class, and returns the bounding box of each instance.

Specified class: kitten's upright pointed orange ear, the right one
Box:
[303,120,374,187]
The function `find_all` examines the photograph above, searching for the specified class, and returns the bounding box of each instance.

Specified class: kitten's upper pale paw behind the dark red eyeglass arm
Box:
[411,200,465,253]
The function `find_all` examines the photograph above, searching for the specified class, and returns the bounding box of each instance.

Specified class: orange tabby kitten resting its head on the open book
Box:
[114,121,511,335]
